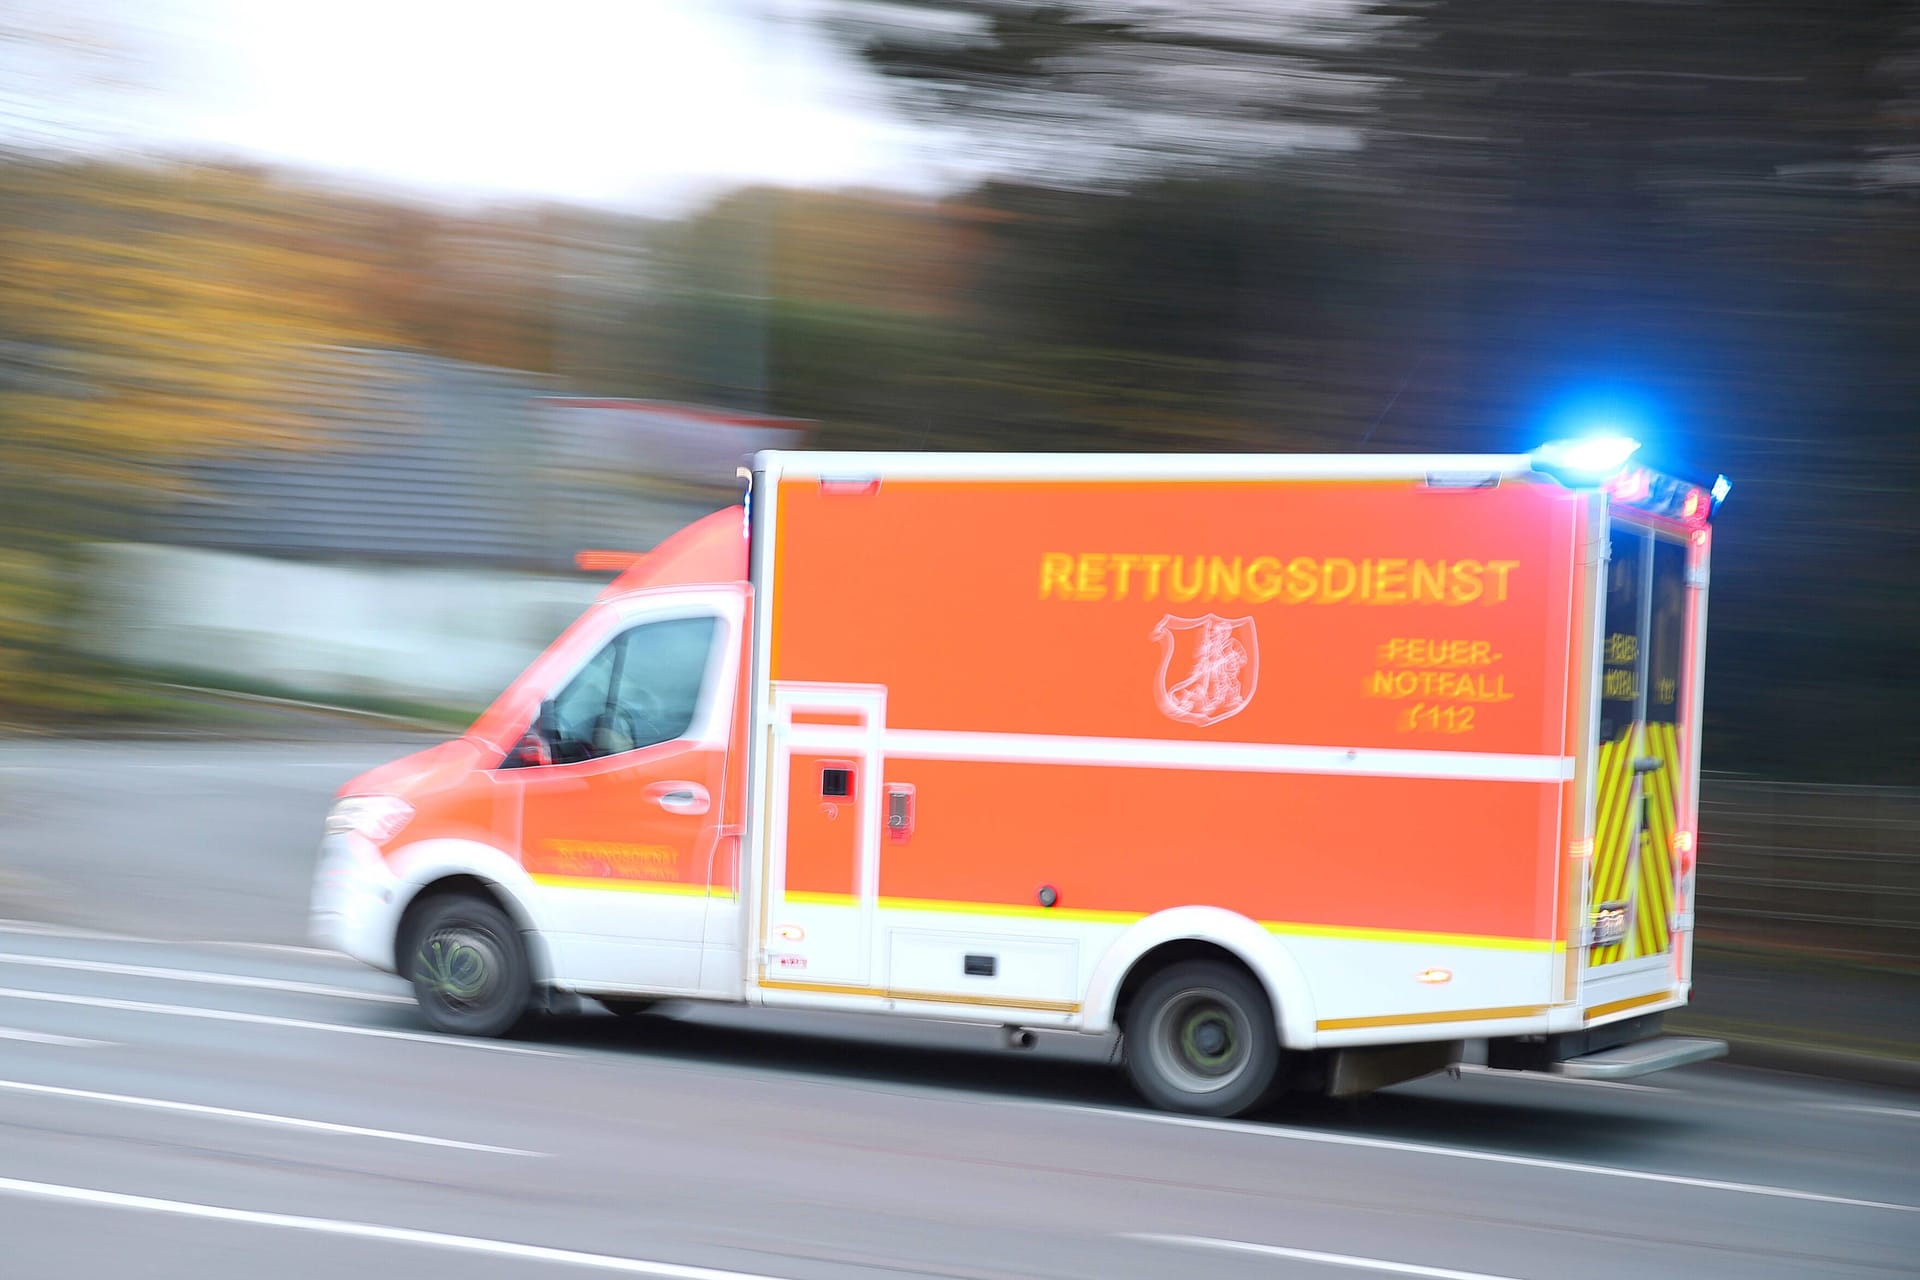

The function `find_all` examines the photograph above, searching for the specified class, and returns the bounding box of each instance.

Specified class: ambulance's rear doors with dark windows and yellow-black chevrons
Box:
[1588,520,1705,982]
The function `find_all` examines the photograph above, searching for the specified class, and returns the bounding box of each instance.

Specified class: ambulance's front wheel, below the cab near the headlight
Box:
[407,894,534,1036]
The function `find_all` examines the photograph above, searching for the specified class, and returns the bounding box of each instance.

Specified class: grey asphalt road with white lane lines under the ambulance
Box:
[0,745,1920,1280]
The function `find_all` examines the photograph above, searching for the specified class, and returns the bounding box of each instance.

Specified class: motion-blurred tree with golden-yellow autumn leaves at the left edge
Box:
[0,159,399,721]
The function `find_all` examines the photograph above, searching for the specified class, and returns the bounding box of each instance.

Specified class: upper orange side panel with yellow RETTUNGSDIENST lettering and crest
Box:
[770,480,1580,756]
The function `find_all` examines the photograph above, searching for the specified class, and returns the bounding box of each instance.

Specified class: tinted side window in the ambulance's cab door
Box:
[547,616,718,762]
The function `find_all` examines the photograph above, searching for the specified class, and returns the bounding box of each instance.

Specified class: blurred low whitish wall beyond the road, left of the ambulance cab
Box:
[83,545,605,706]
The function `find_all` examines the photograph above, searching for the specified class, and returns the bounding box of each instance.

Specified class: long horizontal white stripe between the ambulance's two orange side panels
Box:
[789,725,1572,783]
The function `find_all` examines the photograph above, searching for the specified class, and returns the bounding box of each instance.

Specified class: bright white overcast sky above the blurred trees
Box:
[0,0,935,213]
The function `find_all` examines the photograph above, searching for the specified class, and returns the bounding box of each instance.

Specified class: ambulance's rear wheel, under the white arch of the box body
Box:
[1123,960,1284,1117]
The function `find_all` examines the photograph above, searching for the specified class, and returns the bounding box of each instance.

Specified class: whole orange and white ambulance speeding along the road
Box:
[313,441,1724,1115]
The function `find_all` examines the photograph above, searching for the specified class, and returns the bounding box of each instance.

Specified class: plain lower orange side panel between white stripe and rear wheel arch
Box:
[879,760,1559,938]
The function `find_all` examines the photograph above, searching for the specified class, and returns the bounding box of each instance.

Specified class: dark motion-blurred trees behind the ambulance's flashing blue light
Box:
[828,0,1920,781]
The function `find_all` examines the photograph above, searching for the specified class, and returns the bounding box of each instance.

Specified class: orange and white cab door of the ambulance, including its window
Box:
[516,604,739,992]
